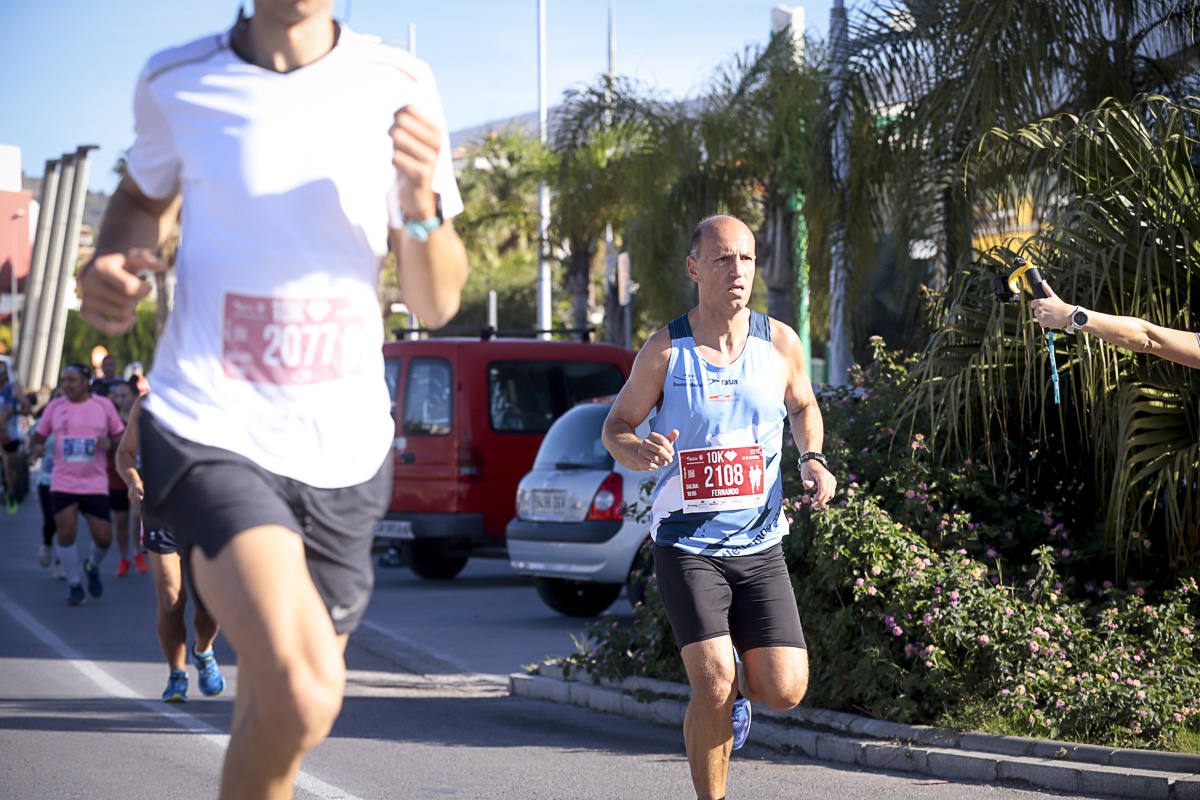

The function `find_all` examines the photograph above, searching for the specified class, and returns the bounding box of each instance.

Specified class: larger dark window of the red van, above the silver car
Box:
[487,361,625,433]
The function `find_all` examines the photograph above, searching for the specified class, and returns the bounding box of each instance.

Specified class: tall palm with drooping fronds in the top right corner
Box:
[816,0,1200,379]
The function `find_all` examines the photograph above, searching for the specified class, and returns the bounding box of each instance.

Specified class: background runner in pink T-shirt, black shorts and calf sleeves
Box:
[32,363,125,606]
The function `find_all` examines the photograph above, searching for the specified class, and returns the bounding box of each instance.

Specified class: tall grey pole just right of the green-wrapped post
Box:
[826,0,851,386]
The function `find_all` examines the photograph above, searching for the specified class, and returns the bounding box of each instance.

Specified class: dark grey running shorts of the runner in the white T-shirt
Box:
[138,411,391,633]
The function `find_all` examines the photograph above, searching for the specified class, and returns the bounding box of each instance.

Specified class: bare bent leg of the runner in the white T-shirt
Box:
[192,525,346,800]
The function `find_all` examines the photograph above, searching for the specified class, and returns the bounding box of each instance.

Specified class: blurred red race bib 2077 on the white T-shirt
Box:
[221,294,366,386]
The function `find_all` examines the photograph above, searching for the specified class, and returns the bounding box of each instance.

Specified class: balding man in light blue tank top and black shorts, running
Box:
[604,216,836,800]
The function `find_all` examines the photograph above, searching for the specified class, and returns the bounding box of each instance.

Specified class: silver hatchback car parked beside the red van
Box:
[505,398,659,616]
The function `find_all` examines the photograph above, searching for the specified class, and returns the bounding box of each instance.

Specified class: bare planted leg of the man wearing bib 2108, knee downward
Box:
[680,636,737,800]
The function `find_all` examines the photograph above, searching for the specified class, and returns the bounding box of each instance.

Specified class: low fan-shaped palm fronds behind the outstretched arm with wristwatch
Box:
[902,96,1200,572]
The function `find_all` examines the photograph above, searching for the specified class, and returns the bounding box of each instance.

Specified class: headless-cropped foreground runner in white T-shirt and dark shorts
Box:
[80,0,467,798]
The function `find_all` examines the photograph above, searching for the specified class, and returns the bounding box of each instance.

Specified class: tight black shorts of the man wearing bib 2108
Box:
[654,545,806,652]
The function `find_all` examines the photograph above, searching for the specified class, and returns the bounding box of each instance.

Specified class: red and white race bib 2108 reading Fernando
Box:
[679,445,767,513]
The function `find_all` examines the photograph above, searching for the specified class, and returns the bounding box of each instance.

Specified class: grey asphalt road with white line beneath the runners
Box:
[0,499,1113,800]
